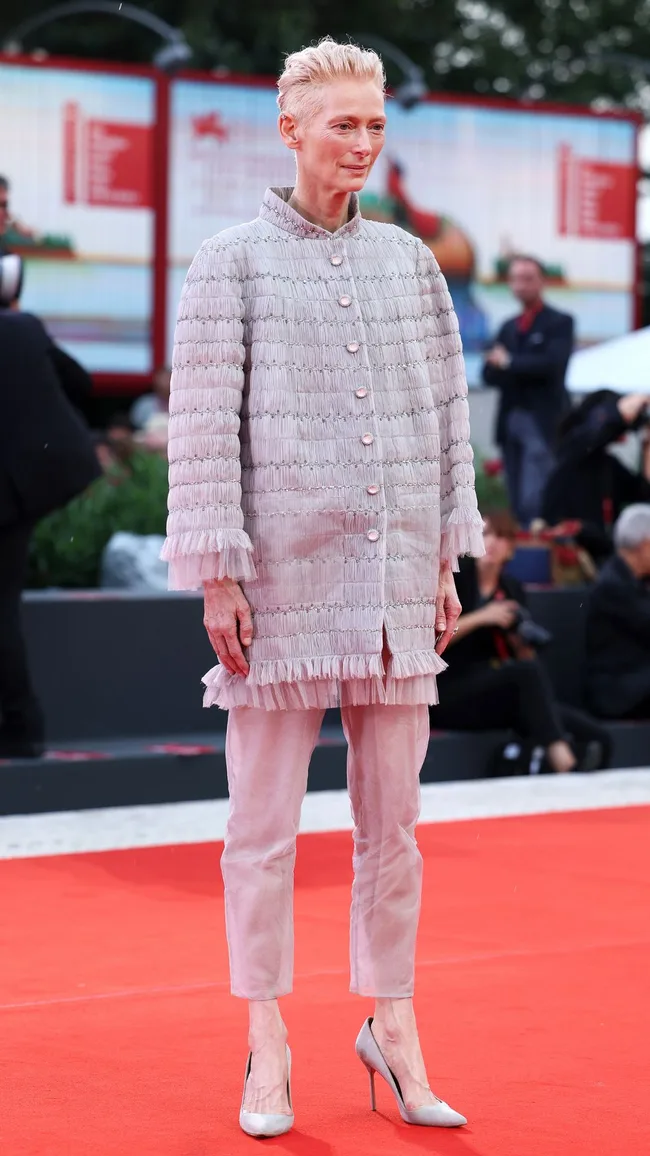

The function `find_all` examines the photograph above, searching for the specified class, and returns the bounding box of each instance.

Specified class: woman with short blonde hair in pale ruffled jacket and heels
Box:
[163,39,482,1135]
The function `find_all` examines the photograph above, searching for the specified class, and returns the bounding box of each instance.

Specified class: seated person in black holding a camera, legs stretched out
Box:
[430,511,611,771]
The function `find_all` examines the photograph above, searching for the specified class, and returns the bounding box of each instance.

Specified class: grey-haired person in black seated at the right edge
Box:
[586,504,650,719]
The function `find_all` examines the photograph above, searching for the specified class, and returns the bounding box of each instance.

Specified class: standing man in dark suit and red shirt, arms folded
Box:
[483,257,574,526]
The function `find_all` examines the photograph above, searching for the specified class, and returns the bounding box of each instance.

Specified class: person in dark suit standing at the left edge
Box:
[0,254,101,758]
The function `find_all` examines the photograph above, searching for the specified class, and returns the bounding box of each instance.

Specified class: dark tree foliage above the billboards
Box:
[0,0,650,110]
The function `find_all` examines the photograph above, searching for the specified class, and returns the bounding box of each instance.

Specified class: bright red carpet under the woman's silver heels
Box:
[0,808,650,1156]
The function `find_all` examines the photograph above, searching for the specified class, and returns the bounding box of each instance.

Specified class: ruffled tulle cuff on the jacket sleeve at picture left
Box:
[161,529,257,590]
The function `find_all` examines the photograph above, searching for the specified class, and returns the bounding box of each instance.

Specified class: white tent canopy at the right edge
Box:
[567,326,650,393]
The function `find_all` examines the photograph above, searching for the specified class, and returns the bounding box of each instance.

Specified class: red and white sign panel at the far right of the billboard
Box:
[557,145,636,240]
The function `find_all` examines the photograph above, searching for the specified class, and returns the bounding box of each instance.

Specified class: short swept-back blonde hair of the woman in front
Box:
[278,36,386,117]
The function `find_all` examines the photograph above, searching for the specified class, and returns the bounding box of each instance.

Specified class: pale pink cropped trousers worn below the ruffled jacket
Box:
[221,704,429,1000]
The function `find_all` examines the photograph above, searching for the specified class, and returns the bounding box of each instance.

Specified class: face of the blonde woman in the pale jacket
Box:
[280,79,386,193]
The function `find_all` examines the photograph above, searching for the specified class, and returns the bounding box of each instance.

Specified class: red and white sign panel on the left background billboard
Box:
[64,102,153,209]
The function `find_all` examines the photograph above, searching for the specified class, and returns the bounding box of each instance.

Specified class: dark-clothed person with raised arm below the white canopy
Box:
[542,390,650,562]
